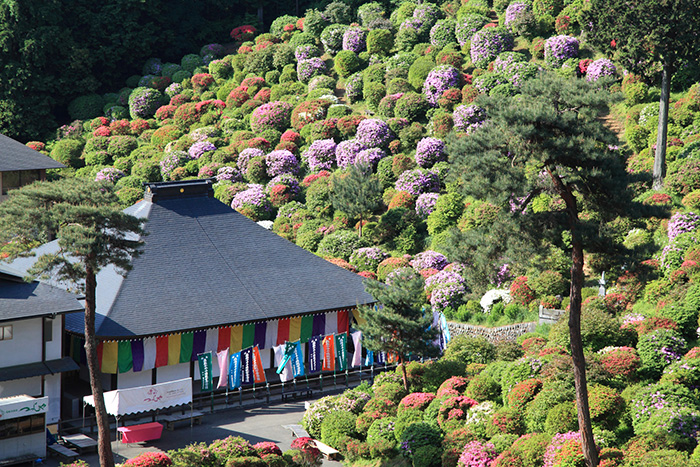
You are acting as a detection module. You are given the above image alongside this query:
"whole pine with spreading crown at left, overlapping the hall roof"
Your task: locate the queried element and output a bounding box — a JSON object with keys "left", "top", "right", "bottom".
{"left": 0, "top": 179, "right": 144, "bottom": 467}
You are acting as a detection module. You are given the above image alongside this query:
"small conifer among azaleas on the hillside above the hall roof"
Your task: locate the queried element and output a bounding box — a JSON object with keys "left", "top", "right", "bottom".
{"left": 331, "top": 164, "right": 382, "bottom": 237}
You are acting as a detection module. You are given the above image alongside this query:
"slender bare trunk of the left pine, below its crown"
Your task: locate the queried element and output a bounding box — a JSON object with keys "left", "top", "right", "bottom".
{"left": 85, "top": 267, "right": 114, "bottom": 467}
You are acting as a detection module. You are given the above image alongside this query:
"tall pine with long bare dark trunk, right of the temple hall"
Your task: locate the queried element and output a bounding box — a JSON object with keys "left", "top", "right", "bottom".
{"left": 448, "top": 75, "right": 644, "bottom": 467}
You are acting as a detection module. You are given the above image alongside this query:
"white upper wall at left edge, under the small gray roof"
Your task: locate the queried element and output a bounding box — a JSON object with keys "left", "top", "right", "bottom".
{"left": 0, "top": 318, "right": 41, "bottom": 368}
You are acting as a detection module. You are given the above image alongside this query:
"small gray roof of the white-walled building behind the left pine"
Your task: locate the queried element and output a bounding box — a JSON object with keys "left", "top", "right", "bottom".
{"left": 0, "top": 265, "right": 84, "bottom": 322}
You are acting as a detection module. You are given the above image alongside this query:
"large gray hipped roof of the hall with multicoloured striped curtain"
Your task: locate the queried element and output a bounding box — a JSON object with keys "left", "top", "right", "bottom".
{"left": 5, "top": 181, "right": 374, "bottom": 338}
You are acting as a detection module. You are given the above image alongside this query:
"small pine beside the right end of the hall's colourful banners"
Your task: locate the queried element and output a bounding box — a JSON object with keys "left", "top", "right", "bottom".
{"left": 358, "top": 270, "right": 440, "bottom": 391}
